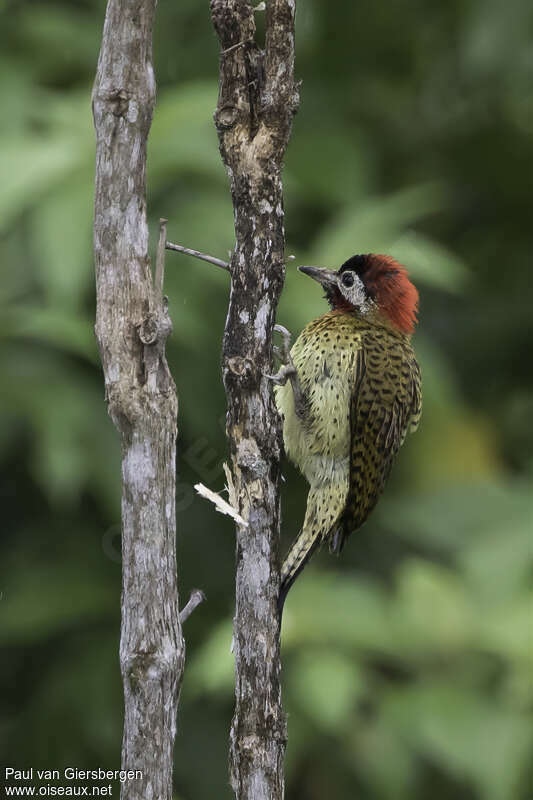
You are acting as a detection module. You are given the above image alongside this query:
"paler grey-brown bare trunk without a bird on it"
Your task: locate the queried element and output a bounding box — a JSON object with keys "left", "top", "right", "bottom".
{"left": 93, "top": 0, "right": 185, "bottom": 800}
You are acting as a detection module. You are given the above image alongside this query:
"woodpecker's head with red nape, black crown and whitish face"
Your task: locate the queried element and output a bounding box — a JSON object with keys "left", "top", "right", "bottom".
{"left": 298, "top": 253, "right": 418, "bottom": 334}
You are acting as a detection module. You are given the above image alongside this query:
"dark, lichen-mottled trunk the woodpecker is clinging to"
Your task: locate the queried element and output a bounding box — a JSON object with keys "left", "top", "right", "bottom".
{"left": 211, "top": 0, "right": 298, "bottom": 800}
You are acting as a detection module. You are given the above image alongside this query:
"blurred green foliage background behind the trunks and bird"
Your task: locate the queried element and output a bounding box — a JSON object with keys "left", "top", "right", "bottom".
{"left": 0, "top": 0, "right": 533, "bottom": 800}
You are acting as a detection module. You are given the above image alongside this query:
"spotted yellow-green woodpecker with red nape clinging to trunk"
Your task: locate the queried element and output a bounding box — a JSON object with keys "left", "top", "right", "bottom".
{"left": 269, "top": 253, "right": 422, "bottom": 614}
